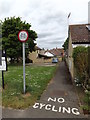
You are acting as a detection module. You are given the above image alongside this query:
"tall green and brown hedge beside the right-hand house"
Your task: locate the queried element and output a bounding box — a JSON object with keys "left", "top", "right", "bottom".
{"left": 73, "top": 46, "right": 89, "bottom": 87}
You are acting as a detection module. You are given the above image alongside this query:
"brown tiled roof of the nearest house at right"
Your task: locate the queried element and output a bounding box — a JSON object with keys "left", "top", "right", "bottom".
{"left": 69, "top": 24, "right": 90, "bottom": 44}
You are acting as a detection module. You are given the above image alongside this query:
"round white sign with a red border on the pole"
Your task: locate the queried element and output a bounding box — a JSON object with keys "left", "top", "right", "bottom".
{"left": 18, "top": 30, "right": 28, "bottom": 42}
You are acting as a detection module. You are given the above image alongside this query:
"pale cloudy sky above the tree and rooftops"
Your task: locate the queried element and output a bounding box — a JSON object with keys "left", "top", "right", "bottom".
{"left": 0, "top": 0, "right": 90, "bottom": 49}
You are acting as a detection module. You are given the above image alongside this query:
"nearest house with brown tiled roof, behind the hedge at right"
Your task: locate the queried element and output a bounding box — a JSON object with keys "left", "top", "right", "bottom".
{"left": 66, "top": 24, "right": 90, "bottom": 79}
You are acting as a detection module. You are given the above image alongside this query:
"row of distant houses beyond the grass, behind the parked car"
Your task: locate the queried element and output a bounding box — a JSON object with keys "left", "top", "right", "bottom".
{"left": 28, "top": 46, "right": 64, "bottom": 63}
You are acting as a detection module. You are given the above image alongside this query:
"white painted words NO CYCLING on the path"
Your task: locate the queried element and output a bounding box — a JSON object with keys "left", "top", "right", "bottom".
{"left": 33, "top": 97, "right": 80, "bottom": 116}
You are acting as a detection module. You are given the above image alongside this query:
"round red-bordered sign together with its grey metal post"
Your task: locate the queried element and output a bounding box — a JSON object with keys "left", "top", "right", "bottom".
{"left": 18, "top": 30, "right": 28, "bottom": 94}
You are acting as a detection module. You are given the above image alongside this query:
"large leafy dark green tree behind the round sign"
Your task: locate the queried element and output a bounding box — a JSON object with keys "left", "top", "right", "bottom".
{"left": 2, "top": 17, "right": 37, "bottom": 61}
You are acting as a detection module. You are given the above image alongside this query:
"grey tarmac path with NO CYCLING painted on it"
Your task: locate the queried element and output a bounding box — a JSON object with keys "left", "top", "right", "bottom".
{"left": 2, "top": 62, "right": 86, "bottom": 118}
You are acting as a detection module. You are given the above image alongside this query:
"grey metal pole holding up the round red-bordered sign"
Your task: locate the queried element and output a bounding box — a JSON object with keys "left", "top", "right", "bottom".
{"left": 23, "top": 42, "right": 26, "bottom": 94}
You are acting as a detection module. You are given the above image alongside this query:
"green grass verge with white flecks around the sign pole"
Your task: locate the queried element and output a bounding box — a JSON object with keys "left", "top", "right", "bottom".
{"left": 2, "top": 66, "right": 56, "bottom": 109}
